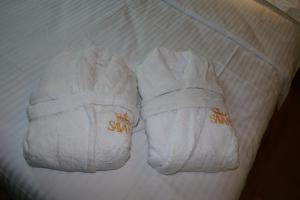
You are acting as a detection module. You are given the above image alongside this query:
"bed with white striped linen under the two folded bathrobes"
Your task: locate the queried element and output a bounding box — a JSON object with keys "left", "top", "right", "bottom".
{"left": 0, "top": 0, "right": 300, "bottom": 200}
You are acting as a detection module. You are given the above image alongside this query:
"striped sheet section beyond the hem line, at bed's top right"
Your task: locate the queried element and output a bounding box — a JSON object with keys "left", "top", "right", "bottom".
{"left": 164, "top": 0, "right": 300, "bottom": 105}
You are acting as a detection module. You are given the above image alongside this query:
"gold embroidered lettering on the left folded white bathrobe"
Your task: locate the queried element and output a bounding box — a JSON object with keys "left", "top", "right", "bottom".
{"left": 107, "top": 112, "right": 132, "bottom": 133}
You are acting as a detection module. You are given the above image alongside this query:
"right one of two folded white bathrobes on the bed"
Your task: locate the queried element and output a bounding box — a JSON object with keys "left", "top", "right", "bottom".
{"left": 137, "top": 48, "right": 238, "bottom": 174}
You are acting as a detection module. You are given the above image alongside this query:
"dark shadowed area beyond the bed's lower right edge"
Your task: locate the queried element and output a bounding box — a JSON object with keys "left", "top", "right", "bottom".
{"left": 240, "top": 71, "right": 300, "bottom": 200}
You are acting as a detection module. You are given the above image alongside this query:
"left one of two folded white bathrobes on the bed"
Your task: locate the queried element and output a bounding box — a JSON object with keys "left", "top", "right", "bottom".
{"left": 24, "top": 47, "right": 138, "bottom": 172}
